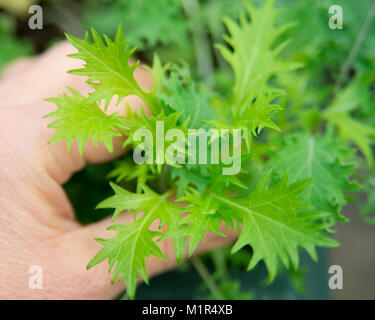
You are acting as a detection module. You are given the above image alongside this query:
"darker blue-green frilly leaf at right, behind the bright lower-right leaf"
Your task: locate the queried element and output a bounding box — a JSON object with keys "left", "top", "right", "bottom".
{"left": 267, "top": 132, "right": 358, "bottom": 221}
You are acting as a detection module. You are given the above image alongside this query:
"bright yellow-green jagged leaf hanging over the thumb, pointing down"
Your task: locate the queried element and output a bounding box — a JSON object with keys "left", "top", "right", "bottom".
{"left": 87, "top": 183, "right": 186, "bottom": 298}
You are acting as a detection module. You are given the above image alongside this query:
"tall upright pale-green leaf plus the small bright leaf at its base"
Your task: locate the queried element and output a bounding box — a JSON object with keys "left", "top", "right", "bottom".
{"left": 211, "top": 1, "right": 300, "bottom": 151}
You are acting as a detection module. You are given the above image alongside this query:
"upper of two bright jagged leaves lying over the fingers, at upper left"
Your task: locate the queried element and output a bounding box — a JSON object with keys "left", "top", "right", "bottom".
{"left": 66, "top": 25, "right": 157, "bottom": 112}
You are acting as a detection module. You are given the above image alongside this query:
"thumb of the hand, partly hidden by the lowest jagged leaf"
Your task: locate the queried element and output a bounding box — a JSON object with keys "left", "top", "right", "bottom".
{"left": 56, "top": 214, "right": 236, "bottom": 299}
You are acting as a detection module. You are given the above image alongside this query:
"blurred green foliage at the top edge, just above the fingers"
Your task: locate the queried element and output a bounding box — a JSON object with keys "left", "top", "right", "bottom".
{"left": 86, "top": 0, "right": 188, "bottom": 49}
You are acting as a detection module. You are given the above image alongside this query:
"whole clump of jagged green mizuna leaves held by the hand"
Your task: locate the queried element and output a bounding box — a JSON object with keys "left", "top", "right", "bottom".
{"left": 47, "top": 1, "right": 375, "bottom": 298}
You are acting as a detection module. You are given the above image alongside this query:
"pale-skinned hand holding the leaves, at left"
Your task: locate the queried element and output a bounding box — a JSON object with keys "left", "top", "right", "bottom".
{"left": 0, "top": 42, "right": 235, "bottom": 299}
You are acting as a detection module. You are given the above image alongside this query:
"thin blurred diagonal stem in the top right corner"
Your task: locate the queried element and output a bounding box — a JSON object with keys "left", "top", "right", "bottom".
{"left": 335, "top": 3, "right": 375, "bottom": 91}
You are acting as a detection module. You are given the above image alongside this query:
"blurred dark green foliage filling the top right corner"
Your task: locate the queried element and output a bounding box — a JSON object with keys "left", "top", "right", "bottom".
{"left": 281, "top": 0, "right": 375, "bottom": 73}
